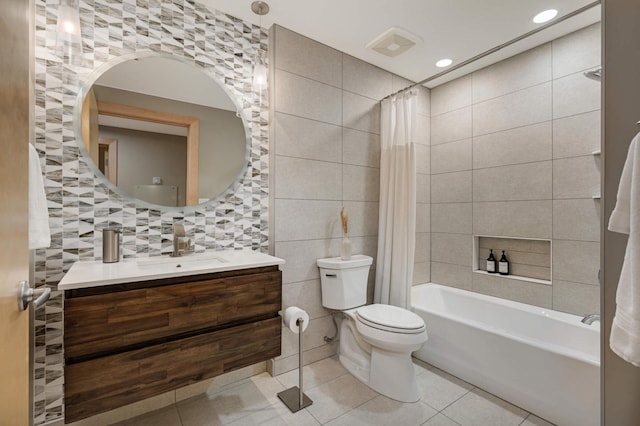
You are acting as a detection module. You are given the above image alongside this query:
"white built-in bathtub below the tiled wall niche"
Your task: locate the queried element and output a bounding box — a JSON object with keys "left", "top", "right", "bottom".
{"left": 411, "top": 284, "right": 600, "bottom": 426}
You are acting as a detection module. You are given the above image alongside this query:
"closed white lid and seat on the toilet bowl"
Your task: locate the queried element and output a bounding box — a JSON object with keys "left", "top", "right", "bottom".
{"left": 356, "top": 304, "right": 425, "bottom": 333}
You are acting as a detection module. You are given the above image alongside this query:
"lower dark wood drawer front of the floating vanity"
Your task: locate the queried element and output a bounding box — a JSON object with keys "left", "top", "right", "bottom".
{"left": 65, "top": 317, "right": 282, "bottom": 422}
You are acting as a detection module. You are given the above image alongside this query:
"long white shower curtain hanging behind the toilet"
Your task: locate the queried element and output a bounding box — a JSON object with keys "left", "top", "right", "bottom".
{"left": 374, "top": 90, "right": 416, "bottom": 308}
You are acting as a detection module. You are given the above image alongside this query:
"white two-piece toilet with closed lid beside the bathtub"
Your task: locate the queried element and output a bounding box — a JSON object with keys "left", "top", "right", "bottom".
{"left": 317, "top": 255, "right": 427, "bottom": 402}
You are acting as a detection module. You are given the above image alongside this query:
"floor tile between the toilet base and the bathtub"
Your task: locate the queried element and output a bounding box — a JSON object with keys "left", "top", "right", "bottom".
{"left": 416, "top": 368, "right": 473, "bottom": 411}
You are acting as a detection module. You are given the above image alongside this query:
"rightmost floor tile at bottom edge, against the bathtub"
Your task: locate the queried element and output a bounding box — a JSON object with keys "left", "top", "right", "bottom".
{"left": 442, "top": 388, "right": 529, "bottom": 426}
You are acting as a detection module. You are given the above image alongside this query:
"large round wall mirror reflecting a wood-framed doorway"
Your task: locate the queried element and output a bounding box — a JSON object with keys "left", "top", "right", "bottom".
{"left": 76, "top": 52, "right": 249, "bottom": 207}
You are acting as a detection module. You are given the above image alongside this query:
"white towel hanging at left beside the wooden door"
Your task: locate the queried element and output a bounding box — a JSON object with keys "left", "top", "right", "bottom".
{"left": 28, "top": 144, "right": 51, "bottom": 250}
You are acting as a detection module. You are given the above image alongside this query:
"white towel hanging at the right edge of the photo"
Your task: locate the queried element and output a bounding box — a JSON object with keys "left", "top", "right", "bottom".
{"left": 609, "top": 133, "right": 640, "bottom": 367}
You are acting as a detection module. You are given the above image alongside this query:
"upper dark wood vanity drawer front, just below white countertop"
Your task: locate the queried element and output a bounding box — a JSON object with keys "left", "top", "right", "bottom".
{"left": 64, "top": 267, "right": 282, "bottom": 364}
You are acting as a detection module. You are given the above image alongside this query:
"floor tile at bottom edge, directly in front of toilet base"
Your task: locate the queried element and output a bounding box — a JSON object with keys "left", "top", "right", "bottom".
{"left": 327, "top": 395, "right": 437, "bottom": 426}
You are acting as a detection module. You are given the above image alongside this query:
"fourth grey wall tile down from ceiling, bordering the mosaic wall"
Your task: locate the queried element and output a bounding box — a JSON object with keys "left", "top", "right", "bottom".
{"left": 275, "top": 156, "right": 342, "bottom": 200}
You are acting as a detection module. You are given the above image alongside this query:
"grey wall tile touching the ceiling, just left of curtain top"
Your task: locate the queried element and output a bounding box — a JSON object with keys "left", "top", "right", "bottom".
{"left": 342, "top": 55, "right": 392, "bottom": 100}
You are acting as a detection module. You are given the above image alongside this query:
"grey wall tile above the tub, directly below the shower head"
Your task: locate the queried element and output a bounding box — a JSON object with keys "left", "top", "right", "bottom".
{"left": 553, "top": 72, "right": 601, "bottom": 119}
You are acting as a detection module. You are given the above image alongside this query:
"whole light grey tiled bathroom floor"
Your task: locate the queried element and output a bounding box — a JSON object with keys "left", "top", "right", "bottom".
{"left": 112, "top": 357, "right": 552, "bottom": 426}
